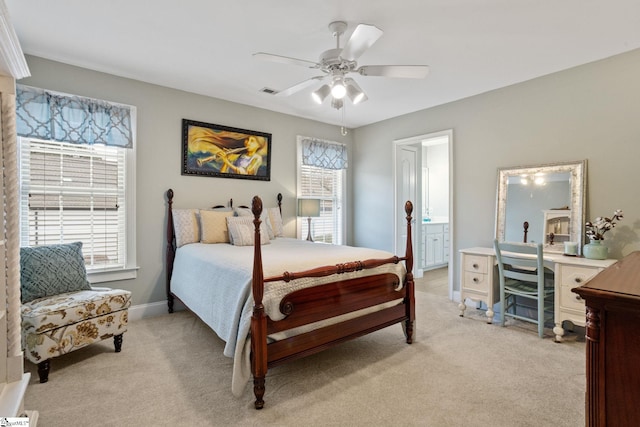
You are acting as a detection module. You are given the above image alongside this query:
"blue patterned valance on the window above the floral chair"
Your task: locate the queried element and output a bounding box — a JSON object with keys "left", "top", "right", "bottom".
{"left": 16, "top": 85, "right": 135, "bottom": 148}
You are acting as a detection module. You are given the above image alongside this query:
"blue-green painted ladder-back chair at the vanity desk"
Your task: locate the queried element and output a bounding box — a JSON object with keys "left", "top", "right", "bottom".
{"left": 493, "top": 240, "right": 554, "bottom": 338}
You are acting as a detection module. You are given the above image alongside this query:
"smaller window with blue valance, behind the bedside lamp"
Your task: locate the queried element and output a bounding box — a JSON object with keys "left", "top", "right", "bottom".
{"left": 298, "top": 137, "right": 346, "bottom": 245}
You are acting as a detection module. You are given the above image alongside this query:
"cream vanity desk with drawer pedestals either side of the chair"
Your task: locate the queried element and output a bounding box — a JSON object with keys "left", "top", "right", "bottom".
{"left": 458, "top": 247, "right": 616, "bottom": 342}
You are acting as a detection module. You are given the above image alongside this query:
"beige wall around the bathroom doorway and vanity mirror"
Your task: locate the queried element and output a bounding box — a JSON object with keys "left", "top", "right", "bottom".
{"left": 352, "top": 50, "right": 640, "bottom": 289}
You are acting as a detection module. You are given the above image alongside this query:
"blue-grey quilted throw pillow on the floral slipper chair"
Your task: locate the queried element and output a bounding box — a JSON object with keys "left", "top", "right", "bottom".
{"left": 20, "top": 242, "right": 91, "bottom": 303}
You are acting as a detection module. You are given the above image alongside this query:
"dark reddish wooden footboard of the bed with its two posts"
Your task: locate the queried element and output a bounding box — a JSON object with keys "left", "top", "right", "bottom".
{"left": 251, "top": 196, "right": 415, "bottom": 409}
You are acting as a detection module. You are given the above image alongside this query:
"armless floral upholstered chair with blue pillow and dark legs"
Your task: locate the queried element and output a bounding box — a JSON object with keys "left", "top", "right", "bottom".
{"left": 20, "top": 242, "right": 131, "bottom": 383}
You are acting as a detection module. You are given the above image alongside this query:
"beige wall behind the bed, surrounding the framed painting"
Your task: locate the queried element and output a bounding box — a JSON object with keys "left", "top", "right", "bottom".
{"left": 18, "top": 57, "right": 351, "bottom": 304}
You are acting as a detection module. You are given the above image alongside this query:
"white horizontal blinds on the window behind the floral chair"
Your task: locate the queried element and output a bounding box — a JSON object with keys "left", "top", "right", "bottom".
{"left": 20, "top": 138, "right": 126, "bottom": 270}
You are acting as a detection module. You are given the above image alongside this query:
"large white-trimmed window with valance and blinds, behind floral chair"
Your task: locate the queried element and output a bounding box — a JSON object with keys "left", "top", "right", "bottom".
{"left": 16, "top": 85, "right": 136, "bottom": 283}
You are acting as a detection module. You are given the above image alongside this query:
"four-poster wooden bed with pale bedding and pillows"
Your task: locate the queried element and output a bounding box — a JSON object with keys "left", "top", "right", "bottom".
{"left": 166, "top": 190, "right": 415, "bottom": 409}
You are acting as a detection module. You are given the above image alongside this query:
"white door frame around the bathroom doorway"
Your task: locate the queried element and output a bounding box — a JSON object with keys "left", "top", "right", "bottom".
{"left": 393, "top": 129, "right": 455, "bottom": 300}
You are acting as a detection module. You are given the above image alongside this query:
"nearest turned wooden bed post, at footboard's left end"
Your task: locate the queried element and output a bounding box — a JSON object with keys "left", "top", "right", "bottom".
{"left": 251, "top": 196, "right": 267, "bottom": 409}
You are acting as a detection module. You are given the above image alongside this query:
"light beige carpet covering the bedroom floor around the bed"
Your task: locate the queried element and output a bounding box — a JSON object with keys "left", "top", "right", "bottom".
{"left": 25, "top": 270, "right": 585, "bottom": 427}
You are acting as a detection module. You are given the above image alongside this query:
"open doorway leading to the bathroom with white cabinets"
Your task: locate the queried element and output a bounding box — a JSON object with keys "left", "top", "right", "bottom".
{"left": 394, "top": 130, "right": 453, "bottom": 299}
